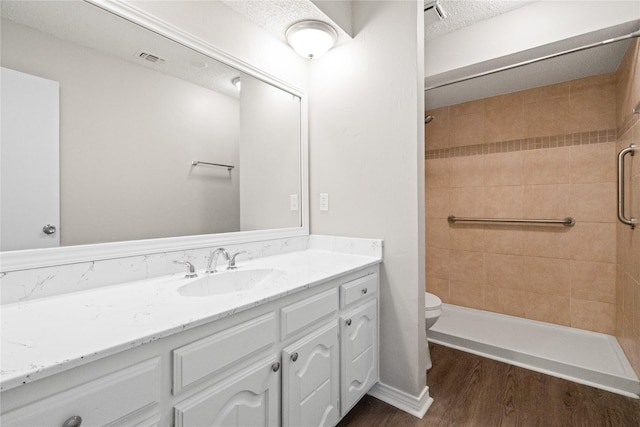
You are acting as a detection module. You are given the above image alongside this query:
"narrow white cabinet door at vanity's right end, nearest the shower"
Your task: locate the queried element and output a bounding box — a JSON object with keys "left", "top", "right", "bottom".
{"left": 340, "top": 299, "right": 378, "bottom": 416}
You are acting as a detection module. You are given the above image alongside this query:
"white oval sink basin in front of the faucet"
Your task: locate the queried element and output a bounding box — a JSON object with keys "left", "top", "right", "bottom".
{"left": 178, "top": 269, "right": 281, "bottom": 297}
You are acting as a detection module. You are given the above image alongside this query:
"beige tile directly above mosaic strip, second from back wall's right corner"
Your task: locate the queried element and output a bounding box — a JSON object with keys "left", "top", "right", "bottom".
{"left": 524, "top": 94, "right": 572, "bottom": 138}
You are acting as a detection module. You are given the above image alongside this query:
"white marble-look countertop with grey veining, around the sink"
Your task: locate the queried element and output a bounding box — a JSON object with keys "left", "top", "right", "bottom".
{"left": 0, "top": 249, "right": 381, "bottom": 390}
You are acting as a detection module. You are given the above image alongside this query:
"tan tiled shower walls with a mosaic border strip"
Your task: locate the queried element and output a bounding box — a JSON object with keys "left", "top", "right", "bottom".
{"left": 425, "top": 39, "right": 640, "bottom": 373}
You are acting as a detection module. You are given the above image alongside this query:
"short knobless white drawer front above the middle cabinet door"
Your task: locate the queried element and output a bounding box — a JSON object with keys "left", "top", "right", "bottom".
{"left": 280, "top": 288, "right": 338, "bottom": 339}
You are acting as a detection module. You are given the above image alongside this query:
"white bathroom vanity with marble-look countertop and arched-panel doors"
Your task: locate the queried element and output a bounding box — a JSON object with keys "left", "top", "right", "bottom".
{"left": 1, "top": 249, "right": 380, "bottom": 427}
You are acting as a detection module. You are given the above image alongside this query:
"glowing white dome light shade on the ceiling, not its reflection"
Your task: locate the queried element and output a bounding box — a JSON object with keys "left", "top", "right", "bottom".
{"left": 286, "top": 21, "right": 338, "bottom": 59}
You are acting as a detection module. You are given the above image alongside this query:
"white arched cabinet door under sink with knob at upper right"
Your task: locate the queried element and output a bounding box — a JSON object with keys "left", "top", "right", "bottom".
{"left": 174, "top": 358, "right": 280, "bottom": 427}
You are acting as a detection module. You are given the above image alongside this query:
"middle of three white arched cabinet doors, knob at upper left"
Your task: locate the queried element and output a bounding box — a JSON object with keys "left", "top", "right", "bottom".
{"left": 282, "top": 321, "right": 340, "bottom": 427}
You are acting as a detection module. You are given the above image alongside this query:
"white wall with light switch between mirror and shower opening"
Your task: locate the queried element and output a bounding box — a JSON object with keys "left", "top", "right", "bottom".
{"left": 309, "top": 1, "right": 426, "bottom": 397}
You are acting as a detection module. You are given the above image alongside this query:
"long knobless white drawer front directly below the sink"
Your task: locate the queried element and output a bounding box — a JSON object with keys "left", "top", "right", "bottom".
{"left": 173, "top": 313, "right": 277, "bottom": 395}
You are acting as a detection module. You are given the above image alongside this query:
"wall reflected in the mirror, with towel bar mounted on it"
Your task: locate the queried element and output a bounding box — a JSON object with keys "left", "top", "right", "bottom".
{"left": 2, "top": 20, "right": 239, "bottom": 246}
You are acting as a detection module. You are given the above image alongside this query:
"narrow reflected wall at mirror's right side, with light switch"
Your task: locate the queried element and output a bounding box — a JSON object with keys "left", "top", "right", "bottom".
{"left": 238, "top": 77, "right": 302, "bottom": 231}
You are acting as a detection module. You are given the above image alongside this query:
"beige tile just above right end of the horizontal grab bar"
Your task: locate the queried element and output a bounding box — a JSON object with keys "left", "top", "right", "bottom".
{"left": 524, "top": 184, "right": 573, "bottom": 219}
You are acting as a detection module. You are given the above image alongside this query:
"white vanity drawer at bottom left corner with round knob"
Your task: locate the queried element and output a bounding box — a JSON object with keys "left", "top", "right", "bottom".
{"left": 2, "top": 357, "right": 160, "bottom": 427}
